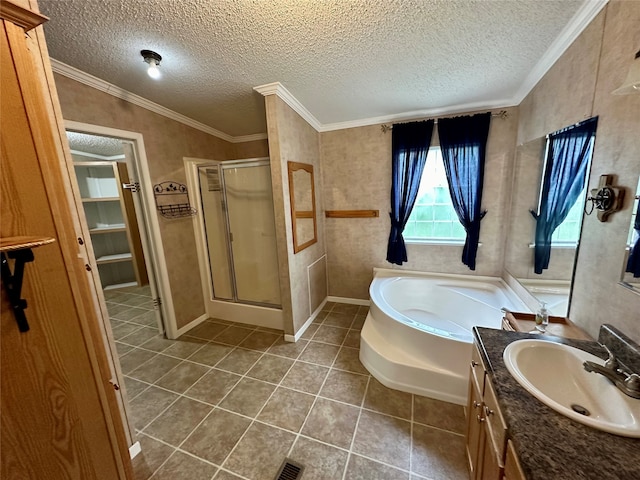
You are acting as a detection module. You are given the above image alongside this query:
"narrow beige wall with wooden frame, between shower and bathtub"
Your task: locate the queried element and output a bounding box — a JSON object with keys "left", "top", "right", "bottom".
{"left": 265, "top": 95, "right": 325, "bottom": 335}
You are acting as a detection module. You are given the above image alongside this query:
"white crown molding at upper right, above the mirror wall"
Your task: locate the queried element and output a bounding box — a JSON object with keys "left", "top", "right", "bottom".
{"left": 513, "top": 0, "right": 609, "bottom": 105}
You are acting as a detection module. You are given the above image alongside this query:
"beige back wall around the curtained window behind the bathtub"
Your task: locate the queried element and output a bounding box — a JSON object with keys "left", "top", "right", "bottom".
{"left": 321, "top": 108, "right": 518, "bottom": 299}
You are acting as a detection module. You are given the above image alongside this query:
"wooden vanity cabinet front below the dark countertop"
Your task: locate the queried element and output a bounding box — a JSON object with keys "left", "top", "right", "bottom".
{"left": 466, "top": 344, "right": 507, "bottom": 480}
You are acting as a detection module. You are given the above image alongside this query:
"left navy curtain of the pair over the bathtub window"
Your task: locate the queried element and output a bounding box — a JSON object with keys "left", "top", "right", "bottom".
{"left": 387, "top": 120, "right": 434, "bottom": 265}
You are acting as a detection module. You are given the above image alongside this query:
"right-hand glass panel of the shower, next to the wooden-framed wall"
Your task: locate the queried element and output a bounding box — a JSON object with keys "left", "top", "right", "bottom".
{"left": 222, "top": 164, "right": 280, "bottom": 305}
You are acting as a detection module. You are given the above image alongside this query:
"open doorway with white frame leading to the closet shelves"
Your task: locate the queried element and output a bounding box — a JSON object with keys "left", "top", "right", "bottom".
{"left": 65, "top": 121, "right": 172, "bottom": 338}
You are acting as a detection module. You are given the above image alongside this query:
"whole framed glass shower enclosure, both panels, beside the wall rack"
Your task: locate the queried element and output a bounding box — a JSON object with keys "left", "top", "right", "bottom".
{"left": 197, "top": 159, "right": 280, "bottom": 308}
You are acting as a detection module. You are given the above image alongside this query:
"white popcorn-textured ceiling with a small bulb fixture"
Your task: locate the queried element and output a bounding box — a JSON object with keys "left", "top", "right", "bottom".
{"left": 39, "top": 0, "right": 593, "bottom": 136}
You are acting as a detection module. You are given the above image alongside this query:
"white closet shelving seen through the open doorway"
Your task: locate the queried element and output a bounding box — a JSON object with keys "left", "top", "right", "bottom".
{"left": 74, "top": 160, "right": 148, "bottom": 288}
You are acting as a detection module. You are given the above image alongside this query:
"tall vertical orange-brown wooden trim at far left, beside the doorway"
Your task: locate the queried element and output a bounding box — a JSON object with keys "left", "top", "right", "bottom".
{"left": 9, "top": 0, "right": 133, "bottom": 478}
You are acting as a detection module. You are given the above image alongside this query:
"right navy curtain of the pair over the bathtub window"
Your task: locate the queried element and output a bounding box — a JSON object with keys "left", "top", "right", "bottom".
{"left": 438, "top": 113, "right": 491, "bottom": 270}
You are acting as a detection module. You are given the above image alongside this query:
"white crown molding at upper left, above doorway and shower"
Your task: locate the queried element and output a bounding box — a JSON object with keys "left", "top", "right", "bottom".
{"left": 51, "top": 58, "right": 267, "bottom": 143}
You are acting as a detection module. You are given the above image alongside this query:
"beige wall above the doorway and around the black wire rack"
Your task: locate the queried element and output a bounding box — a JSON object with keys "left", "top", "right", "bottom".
{"left": 55, "top": 74, "right": 236, "bottom": 328}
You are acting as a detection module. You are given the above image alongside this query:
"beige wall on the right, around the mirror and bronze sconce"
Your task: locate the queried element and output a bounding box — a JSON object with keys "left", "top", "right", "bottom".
{"left": 519, "top": 0, "right": 640, "bottom": 342}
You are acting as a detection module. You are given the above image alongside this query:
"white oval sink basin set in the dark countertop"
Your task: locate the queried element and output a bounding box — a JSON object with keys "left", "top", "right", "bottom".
{"left": 503, "top": 340, "right": 640, "bottom": 438}
